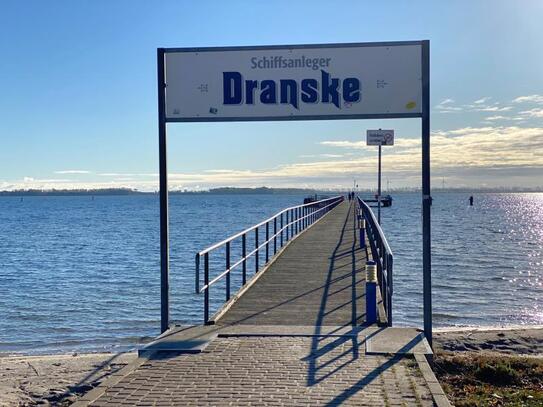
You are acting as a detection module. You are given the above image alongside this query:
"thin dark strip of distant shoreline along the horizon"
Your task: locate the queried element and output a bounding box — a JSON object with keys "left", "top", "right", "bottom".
{"left": 0, "top": 187, "right": 543, "bottom": 197}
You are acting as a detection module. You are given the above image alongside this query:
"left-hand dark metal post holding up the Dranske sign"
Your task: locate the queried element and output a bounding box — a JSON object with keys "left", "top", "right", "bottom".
{"left": 157, "top": 48, "right": 170, "bottom": 332}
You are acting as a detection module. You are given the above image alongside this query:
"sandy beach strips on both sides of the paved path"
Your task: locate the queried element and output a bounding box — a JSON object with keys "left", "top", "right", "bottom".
{"left": 0, "top": 327, "right": 543, "bottom": 406}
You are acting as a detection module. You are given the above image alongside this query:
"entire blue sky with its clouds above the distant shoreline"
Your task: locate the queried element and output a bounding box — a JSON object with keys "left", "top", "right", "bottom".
{"left": 0, "top": 0, "right": 543, "bottom": 190}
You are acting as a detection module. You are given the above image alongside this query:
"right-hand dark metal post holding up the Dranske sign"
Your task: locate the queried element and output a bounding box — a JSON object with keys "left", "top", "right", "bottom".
{"left": 422, "top": 41, "right": 432, "bottom": 346}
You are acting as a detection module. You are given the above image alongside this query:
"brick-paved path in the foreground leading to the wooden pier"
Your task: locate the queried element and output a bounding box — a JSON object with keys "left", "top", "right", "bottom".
{"left": 91, "top": 336, "right": 433, "bottom": 407}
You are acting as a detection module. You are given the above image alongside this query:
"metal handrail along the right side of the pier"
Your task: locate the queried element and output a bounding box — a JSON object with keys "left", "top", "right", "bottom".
{"left": 357, "top": 198, "right": 394, "bottom": 325}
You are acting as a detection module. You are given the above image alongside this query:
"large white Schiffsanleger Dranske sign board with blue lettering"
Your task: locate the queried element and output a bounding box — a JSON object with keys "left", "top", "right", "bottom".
{"left": 164, "top": 42, "right": 422, "bottom": 121}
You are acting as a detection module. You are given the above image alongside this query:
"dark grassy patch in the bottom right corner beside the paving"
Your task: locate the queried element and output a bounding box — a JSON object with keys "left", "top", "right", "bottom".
{"left": 434, "top": 353, "right": 543, "bottom": 407}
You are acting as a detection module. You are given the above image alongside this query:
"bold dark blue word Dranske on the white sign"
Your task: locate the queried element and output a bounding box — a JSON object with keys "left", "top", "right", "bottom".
{"left": 222, "top": 70, "right": 361, "bottom": 109}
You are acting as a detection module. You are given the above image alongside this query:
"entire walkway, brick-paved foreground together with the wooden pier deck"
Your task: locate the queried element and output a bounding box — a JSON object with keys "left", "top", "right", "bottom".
{"left": 75, "top": 201, "right": 449, "bottom": 407}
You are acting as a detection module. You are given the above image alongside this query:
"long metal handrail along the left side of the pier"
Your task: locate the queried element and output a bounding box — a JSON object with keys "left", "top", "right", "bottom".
{"left": 195, "top": 196, "right": 344, "bottom": 324}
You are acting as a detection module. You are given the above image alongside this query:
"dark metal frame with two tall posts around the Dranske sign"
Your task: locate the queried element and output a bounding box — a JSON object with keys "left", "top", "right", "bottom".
{"left": 157, "top": 40, "right": 432, "bottom": 345}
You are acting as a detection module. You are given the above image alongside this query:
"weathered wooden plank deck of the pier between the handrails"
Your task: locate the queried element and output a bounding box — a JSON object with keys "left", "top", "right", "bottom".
{"left": 217, "top": 201, "right": 367, "bottom": 326}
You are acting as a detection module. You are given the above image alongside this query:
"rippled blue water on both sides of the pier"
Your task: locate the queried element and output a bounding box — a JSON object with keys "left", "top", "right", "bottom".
{"left": 0, "top": 193, "right": 543, "bottom": 352}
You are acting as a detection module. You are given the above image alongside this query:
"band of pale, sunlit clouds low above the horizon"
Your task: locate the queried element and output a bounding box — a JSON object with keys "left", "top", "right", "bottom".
{"left": 4, "top": 126, "right": 543, "bottom": 191}
